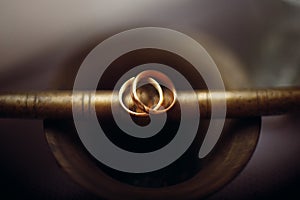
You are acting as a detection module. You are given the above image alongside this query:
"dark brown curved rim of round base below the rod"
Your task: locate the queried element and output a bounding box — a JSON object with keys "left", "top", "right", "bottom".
{"left": 44, "top": 118, "right": 261, "bottom": 199}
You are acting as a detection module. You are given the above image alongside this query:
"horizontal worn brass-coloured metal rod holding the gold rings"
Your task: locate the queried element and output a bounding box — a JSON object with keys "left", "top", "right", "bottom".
{"left": 0, "top": 88, "right": 300, "bottom": 119}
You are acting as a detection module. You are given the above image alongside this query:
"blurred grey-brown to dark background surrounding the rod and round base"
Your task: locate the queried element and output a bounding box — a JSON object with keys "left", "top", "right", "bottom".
{"left": 0, "top": 0, "right": 300, "bottom": 200}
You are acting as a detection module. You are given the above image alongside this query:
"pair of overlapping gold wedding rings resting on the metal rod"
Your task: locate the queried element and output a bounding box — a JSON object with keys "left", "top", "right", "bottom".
{"left": 119, "top": 70, "right": 177, "bottom": 116}
